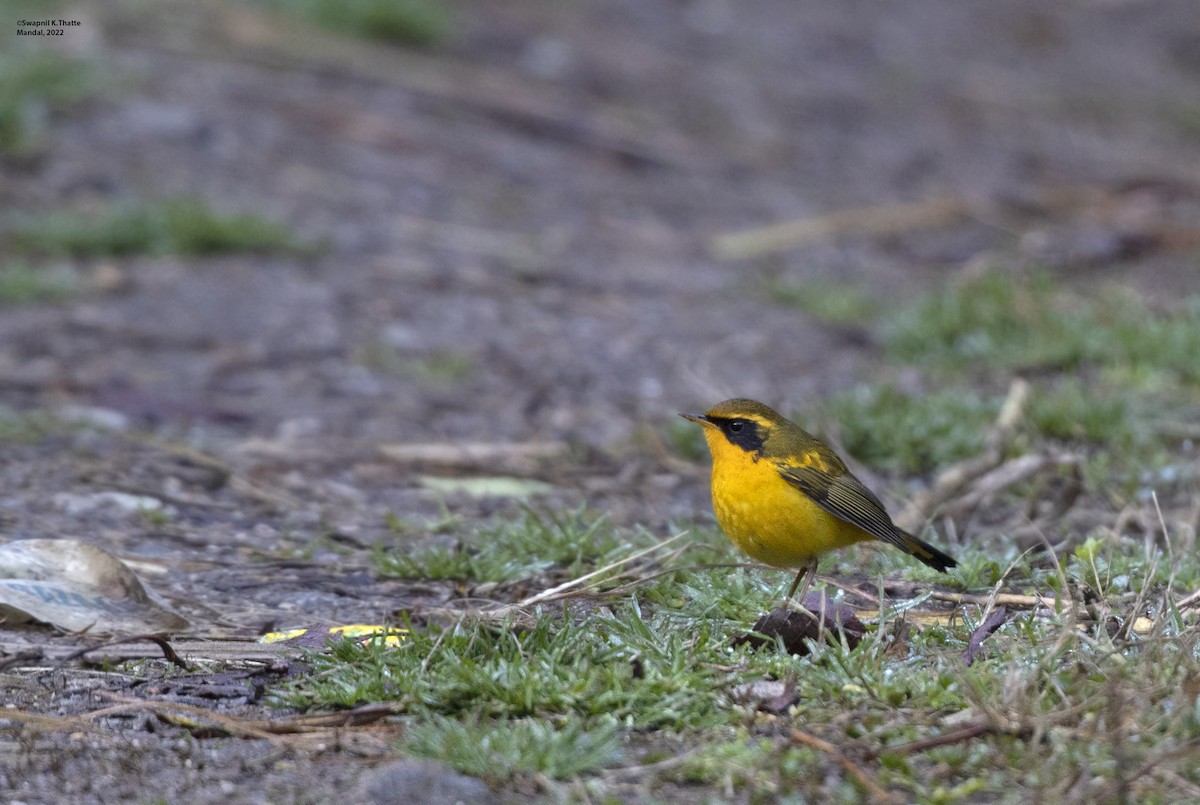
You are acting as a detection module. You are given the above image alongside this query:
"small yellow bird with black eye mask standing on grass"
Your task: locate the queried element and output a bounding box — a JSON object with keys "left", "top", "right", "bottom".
{"left": 679, "top": 400, "right": 958, "bottom": 603}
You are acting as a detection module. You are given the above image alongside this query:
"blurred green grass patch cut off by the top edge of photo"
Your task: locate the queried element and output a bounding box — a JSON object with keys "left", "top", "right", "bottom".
{"left": 274, "top": 0, "right": 454, "bottom": 47}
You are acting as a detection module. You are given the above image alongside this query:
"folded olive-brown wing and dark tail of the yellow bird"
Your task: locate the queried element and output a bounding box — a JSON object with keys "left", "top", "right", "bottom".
{"left": 779, "top": 467, "right": 958, "bottom": 571}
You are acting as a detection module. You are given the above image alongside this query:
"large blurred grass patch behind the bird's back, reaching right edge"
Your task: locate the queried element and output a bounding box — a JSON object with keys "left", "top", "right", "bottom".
{"left": 859, "top": 272, "right": 1200, "bottom": 494}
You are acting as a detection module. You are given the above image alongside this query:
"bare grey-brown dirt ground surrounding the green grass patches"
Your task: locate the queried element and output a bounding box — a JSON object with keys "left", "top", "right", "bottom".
{"left": 0, "top": 0, "right": 1200, "bottom": 803}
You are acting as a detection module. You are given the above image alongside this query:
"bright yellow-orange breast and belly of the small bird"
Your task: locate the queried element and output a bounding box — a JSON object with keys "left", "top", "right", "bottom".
{"left": 706, "top": 433, "right": 871, "bottom": 567}
